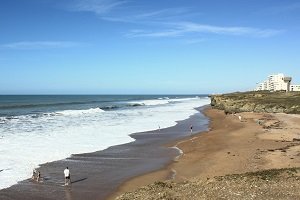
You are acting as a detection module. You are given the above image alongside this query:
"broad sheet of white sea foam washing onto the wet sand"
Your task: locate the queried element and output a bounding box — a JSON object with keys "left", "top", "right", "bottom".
{"left": 0, "top": 98, "right": 209, "bottom": 189}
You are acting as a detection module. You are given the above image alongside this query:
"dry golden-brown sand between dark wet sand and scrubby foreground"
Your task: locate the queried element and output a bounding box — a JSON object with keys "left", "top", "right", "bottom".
{"left": 110, "top": 108, "right": 300, "bottom": 199}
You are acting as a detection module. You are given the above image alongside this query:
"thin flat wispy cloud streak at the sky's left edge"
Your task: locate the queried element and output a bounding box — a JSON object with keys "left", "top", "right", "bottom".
{"left": 0, "top": 41, "right": 81, "bottom": 50}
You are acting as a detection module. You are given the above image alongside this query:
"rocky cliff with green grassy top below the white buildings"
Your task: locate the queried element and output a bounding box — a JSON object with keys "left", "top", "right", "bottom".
{"left": 211, "top": 91, "right": 300, "bottom": 114}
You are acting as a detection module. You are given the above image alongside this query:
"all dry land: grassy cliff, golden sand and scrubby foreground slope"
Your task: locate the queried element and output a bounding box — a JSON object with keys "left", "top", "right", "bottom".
{"left": 111, "top": 92, "right": 300, "bottom": 200}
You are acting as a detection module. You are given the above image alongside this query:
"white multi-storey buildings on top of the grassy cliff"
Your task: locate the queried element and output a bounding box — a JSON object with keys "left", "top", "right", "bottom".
{"left": 255, "top": 73, "right": 300, "bottom": 92}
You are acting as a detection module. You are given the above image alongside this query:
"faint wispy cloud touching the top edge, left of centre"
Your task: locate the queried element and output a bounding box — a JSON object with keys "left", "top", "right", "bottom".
{"left": 69, "top": 0, "right": 127, "bottom": 15}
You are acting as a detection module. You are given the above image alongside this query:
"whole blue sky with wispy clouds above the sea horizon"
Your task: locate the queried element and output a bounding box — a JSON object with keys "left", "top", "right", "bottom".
{"left": 0, "top": 0, "right": 300, "bottom": 94}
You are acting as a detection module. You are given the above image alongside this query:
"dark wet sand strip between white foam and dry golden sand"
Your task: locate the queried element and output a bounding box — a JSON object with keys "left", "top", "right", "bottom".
{"left": 0, "top": 107, "right": 208, "bottom": 200}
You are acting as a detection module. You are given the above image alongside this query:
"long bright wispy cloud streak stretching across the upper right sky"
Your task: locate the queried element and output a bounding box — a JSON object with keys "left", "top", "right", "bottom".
{"left": 127, "top": 22, "right": 284, "bottom": 37}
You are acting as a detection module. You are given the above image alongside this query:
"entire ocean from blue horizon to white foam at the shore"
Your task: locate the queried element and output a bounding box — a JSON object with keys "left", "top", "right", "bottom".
{"left": 0, "top": 95, "right": 210, "bottom": 189}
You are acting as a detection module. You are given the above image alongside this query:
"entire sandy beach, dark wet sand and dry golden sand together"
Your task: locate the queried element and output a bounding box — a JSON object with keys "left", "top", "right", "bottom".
{"left": 0, "top": 104, "right": 300, "bottom": 200}
